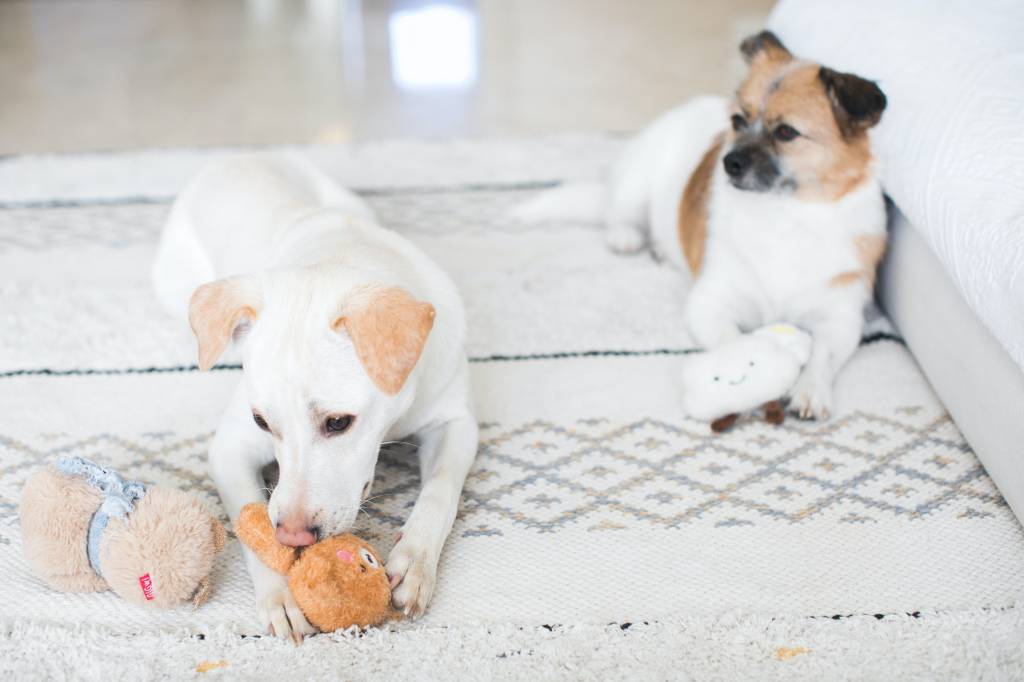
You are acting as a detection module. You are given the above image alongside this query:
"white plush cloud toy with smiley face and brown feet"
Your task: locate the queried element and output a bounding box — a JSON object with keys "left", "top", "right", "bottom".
{"left": 682, "top": 325, "right": 812, "bottom": 431}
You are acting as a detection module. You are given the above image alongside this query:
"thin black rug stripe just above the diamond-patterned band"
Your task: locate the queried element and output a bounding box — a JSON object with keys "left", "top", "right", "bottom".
{"left": 0, "top": 332, "right": 906, "bottom": 379}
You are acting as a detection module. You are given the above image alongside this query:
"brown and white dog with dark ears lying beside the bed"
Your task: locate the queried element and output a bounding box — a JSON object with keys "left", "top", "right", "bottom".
{"left": 517, "top": 32, "right": 886, "bottom": 418}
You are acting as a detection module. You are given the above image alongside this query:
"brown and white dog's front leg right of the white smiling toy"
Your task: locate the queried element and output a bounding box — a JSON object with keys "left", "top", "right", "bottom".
{"left": 790, "top": 303, "right": 864, "bottom": 419}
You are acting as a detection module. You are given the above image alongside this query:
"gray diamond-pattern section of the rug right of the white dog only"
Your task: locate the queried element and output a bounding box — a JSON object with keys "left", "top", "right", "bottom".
{"left": 462, "top": 412, "right": 1005, "bottom": 532}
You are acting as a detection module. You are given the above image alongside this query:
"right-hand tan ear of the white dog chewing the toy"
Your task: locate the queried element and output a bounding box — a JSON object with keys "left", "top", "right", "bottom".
{"left": 332, "top": 287, "right": 434, "bottom": 395}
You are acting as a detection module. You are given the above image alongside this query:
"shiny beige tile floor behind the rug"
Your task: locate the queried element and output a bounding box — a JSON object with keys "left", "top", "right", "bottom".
{"left": 0, "top": 0, "right": 773, "bottom": 154}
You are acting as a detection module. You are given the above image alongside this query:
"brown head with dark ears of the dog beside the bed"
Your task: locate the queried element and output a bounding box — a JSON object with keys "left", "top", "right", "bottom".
{"left": 723, "top": 31, "right": 886, "bottom": 201}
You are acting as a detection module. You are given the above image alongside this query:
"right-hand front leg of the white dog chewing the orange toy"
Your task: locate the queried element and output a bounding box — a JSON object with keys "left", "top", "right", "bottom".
{"left": 387, "top": 415, "right": 478, "bottom": 617}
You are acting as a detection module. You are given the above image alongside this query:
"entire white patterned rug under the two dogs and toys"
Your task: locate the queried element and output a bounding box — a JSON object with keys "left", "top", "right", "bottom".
{"left": 0, "top": 137, "right": 1024, "bottom": 679}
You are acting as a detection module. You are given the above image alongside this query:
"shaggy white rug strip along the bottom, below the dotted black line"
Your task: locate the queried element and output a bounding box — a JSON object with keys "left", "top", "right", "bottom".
{"left": 0, "top": 607, "right": 1024, "bottom": 682}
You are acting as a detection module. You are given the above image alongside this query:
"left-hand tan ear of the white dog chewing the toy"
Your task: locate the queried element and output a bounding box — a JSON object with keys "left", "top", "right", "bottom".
{"left": 188, "top": 275, "right": 263, "bottom": 372}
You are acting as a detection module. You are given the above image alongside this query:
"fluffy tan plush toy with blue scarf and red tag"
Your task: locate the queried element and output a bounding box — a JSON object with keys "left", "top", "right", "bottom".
{"left": 18, "top": 457, "right": 225, "bottom": 608}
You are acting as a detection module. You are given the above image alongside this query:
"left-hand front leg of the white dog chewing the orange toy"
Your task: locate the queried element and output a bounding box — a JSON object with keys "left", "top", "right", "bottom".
{"left": 210, "top": 386, "right": 316, "bottom": 642}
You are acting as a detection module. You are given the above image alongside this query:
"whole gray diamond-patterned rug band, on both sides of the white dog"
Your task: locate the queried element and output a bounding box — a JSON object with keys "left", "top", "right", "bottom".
{"left": 0, "top": 405, "right": 1009, "bottom": 542}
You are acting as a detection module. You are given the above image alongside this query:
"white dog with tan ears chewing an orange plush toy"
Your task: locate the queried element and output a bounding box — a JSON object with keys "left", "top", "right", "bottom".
{"left": 154, "top": 157, "right": 477, "bottom": 639}
